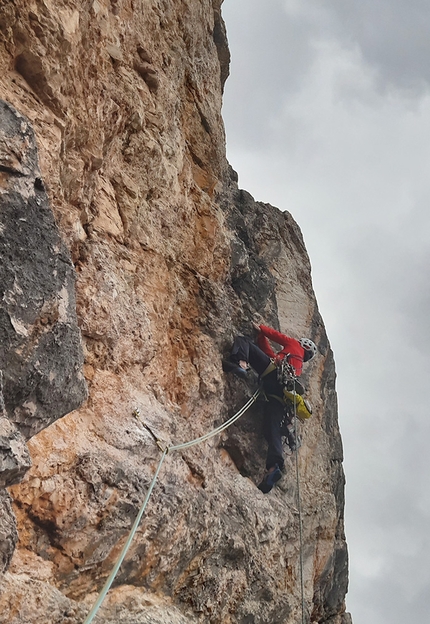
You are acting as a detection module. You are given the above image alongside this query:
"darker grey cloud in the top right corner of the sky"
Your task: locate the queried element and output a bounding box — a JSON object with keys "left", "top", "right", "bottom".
{"left": 279, "top": 0, "right": 430, "bottom": 91}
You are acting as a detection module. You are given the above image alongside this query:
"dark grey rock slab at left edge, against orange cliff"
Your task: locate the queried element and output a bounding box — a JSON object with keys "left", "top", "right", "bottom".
{"left": 0, "top": 101, "right": 86, "bottom": 439}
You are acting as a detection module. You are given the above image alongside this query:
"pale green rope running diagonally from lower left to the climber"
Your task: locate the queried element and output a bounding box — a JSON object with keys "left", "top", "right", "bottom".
{"left": 84, "top": 388, "right": 261, "bottom": 624}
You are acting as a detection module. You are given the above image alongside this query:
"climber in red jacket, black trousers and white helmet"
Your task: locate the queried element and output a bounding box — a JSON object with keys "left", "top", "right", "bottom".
{"left": 223, "top": 323, "right": 317, "bottom": 494}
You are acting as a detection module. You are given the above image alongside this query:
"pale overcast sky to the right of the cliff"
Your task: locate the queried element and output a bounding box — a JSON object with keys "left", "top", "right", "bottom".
{"left": 223, "top": 0, "right": 430, "bottom": 624}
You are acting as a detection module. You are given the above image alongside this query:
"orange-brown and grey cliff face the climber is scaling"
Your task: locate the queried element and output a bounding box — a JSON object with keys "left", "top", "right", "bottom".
{"left": 0, "top": 0, "right": 350, "bottom": 624}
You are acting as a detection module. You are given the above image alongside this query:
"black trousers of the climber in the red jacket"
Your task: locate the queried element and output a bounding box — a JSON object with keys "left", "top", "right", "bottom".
{"left": 230, "top": 336, "right": 285, "bottom": 470}
